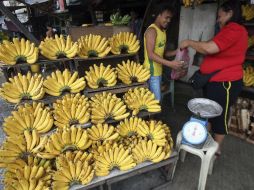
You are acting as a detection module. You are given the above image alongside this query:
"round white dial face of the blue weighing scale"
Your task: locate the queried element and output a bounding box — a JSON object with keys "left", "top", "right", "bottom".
{"left": 182, "top": 121, "right": 207, "bottom": 144}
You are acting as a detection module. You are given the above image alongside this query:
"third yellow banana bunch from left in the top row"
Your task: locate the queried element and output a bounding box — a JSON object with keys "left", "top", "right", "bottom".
{"left": 78, "top": 34, "right": 111, "bottom": 58}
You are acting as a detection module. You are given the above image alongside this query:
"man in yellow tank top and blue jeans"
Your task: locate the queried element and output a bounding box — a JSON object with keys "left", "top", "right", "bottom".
{"left": 144, "top": 5, "right": 183, "bottom": 101}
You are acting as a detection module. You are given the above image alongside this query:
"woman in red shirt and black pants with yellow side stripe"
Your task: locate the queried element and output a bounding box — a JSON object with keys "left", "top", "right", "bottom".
{"left": 180, "top": 0, "right": 248, "bottom": 155}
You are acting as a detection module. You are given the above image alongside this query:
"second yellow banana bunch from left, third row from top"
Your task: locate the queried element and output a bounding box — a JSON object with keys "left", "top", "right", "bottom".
{"left": 53, "top": 93, "right": 90, "bottom": 128}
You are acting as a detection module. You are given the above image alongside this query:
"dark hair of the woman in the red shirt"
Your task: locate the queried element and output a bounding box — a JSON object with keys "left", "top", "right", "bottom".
{"left": 220, "top": 0, "right": 242, "bottom": 24}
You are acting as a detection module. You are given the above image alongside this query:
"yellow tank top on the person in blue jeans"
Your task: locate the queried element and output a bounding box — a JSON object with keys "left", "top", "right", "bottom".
{"left": 144, "top": 24, "right": 166, "bottom": 76}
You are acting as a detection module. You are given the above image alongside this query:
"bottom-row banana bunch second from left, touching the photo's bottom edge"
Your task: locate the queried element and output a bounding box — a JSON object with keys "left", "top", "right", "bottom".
{"left": 52, "top": 151, "right": 95, "bottom": 190}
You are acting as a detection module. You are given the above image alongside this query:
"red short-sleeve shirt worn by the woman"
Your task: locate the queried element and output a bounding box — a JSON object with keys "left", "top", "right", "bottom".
{"left": 200, "top": 22, "right": 248, "bottom": 82}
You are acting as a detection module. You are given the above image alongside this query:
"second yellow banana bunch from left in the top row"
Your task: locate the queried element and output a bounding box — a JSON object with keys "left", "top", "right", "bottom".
{"left": 39, "top": 35, "right": 78, "bottom": 60}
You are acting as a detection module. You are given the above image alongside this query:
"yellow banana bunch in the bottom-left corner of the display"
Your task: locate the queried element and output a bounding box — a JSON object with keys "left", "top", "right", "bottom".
{"left": 4, "top": 156, "right": 52, "bottom": 190}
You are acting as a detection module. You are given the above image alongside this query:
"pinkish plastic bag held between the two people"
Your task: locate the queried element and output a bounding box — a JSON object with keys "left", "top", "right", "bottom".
{"left": 171, "top": 48, "right": 190, "bottom": 80}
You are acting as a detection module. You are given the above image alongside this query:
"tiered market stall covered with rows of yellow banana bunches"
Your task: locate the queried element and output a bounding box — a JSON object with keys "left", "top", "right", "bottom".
{"left": 0, "top": 27, "right": 178, "bottom": 189}
